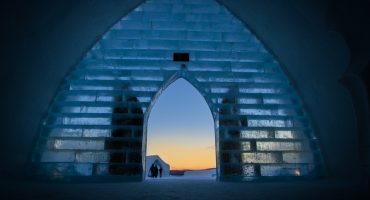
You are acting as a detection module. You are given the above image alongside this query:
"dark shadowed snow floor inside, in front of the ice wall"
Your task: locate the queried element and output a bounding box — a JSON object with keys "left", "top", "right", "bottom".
{"left": 0, "top": 179, "right": 370, "bottom": 200}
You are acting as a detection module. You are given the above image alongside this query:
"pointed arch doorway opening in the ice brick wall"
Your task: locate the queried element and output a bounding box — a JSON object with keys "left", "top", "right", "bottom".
{"left": 143, "top": 75, "right": 216, "bottom": 179}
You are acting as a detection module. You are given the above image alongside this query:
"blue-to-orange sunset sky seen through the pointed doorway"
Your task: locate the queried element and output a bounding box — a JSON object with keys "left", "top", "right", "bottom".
{"left": 147, "top": 79, "right": 216, "bottom": 170}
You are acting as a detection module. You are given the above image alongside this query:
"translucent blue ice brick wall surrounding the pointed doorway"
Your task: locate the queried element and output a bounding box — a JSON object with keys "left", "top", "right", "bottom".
{"left": 33, "top": 0, "right": 321, "bottom": 180}
